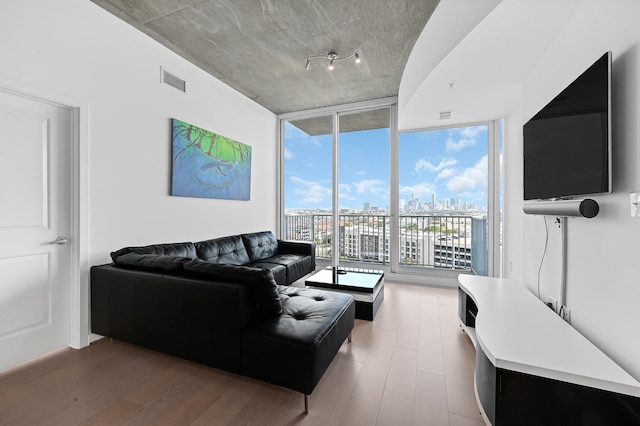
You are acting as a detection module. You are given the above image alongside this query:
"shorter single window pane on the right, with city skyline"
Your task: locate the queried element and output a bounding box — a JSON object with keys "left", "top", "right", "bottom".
{"left": 399, "top": 122, "right": 499, "bottom": 275}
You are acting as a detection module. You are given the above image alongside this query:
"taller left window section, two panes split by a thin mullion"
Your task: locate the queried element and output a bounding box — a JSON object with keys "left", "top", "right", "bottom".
{"left": 280, "top": 102, "right": 391, "bottom": 265}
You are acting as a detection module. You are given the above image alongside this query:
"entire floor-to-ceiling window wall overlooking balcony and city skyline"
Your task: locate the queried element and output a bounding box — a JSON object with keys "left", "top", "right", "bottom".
{"left": 279, "top": 100, "right": 501, "bottom": 277}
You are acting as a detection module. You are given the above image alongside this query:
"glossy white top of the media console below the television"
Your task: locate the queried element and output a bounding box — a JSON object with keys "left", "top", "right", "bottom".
{"left": 458, "top": 275, "right": 640, "bottom": 397}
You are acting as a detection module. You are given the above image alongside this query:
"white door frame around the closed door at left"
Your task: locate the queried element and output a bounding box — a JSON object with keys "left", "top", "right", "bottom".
{"left": 0, "top": 76, "right": 89, "bottom": 349}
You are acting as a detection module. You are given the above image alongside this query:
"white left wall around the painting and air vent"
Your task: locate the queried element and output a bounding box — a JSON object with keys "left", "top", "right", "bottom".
{"left": 0, "top": 0, "right": 276, "bottom": 344}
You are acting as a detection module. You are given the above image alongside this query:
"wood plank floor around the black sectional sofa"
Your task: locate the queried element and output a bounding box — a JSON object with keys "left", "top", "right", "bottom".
{"left": 0, "top": 282, "right": 484, "bottom": 426}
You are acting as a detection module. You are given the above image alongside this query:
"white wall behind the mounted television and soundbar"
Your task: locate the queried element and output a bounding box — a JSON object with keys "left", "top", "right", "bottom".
{"left": 505, "top": 0, "right": 640, "bottom": 378}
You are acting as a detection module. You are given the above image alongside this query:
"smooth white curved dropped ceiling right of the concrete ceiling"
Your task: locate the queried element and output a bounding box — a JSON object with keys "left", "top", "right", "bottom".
{"left": 398, "top": 0, "right": 584, "bottom": 131}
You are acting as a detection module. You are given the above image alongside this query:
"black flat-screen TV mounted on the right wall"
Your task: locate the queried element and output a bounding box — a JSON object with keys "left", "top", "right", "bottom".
{"left": 523, "top": 52, "right": 611, "bottom": 200}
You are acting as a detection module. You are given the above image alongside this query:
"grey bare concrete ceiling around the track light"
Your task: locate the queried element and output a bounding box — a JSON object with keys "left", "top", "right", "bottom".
{"left": 91, "top": 0, "right": 439, "bottom": 120}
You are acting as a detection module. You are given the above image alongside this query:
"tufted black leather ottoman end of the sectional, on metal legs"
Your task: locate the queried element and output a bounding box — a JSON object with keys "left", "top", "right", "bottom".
{"left": 242, "top": 286, "right": 355, "bottom": 411}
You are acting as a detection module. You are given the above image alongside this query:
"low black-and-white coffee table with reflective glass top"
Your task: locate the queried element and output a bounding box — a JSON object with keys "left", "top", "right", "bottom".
{"left": 305, "top": 266, "right": 384, "bottom": 321}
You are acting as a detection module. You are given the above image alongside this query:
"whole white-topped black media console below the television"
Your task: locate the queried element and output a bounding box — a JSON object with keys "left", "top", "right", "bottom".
{"left": 458, "top": 275, "right": 640, "bottom": 426}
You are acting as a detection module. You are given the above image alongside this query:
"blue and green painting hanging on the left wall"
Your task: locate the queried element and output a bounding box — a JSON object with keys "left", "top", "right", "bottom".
{"left": 171, "top": 118, "right": 251, "bottom": 200}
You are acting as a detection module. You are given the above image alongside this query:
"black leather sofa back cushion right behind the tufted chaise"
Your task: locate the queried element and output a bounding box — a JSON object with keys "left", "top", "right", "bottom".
{"left": 184, "top": 259, "right": 282, "bottom": 316}
